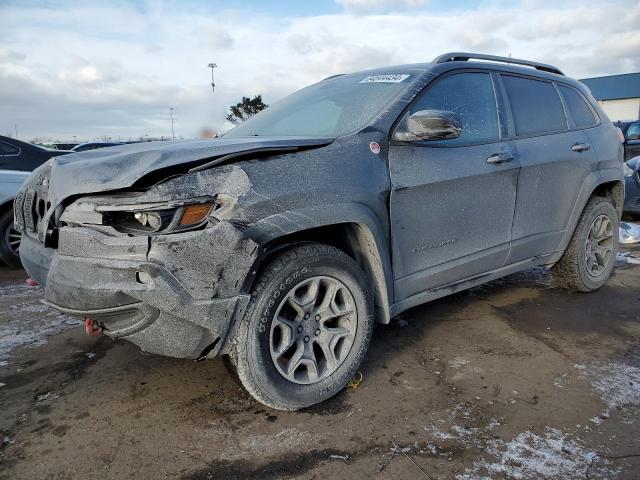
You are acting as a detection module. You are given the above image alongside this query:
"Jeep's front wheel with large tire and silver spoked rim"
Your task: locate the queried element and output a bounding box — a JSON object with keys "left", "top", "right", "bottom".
{"left": 232, "top": 244, "right": 374, "bottom": 410}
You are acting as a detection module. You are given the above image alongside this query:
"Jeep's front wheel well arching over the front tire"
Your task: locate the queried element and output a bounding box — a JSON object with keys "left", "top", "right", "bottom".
{"left": 249, "top": 223, "right": 391, "bottom": 323}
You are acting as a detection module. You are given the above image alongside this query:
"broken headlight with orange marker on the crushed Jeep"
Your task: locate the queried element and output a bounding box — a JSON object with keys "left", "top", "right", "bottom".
{"left": 60, "top": 193, "right": 224, "bottom": 235}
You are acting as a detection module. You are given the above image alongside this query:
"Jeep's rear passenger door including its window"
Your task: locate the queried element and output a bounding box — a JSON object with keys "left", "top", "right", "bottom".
{"left": 501, "top": 73, "right": 596, "bottom": 263}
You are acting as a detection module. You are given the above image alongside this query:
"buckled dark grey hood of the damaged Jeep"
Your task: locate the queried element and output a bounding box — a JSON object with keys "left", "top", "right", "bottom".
{"left": 49, "top": 137, "right": 333, "bottom": 205}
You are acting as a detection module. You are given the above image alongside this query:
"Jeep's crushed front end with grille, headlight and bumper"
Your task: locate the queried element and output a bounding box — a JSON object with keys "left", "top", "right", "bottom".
{"left": 14, "top": 161, "right": 258, "bottom": 358}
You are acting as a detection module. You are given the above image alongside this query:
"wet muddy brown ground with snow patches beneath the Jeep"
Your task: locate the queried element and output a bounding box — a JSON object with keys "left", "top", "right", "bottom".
{"left": 0, "top": 249, "right": 640, "bottom": 479}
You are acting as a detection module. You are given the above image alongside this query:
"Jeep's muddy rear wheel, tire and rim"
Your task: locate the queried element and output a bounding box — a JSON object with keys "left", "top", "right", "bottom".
{"left": 551, "top": 197, "right": 620, "bottom": 292}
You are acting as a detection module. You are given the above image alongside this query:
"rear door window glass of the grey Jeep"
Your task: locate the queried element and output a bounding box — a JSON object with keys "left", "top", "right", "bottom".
{"left": 502, "top": 75, "right": 567, "bottom": 135}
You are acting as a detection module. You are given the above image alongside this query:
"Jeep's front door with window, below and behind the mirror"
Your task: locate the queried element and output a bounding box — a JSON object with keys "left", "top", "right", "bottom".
{"left": 389, "top": 71, "right": 518, "bottom": 301}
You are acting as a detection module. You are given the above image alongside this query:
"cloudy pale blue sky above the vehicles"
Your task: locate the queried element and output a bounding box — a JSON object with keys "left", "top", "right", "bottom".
{"left": 0, "top": 0, "right": 640, "bottom": 141}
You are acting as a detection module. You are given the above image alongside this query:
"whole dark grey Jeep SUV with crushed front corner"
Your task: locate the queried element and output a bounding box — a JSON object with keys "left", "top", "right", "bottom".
{"left": 15, "top": 53, "right": 624, "bottom": 410}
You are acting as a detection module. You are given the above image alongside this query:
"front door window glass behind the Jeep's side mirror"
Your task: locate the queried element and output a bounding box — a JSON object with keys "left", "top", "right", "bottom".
{"left": 399, "top": 73, "right": 498, "bottom": 145}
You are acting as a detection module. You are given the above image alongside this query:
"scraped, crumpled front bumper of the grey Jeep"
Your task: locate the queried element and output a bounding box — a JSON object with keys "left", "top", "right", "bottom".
{"left": 20, "top": 222, "right": 258, "bottom": 358}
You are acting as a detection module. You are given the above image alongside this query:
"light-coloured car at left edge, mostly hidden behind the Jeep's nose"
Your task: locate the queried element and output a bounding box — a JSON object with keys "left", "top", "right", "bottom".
{"left": 0, "top": 170, "right": 31, "bottom": 267}
